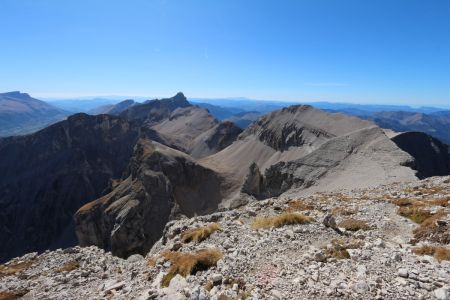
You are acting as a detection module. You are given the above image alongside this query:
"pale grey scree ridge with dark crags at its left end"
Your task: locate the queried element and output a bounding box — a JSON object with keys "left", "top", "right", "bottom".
{"left": 243, "top": 126, "right": 416, "bottom": 198}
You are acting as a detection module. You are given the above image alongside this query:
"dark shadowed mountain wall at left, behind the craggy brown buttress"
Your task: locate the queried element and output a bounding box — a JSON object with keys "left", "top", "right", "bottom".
{"left": 0, "top": 114, "right": 139, "bottom": 260}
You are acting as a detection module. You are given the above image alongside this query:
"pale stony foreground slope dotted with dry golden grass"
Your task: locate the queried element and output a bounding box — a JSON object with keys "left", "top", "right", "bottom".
{"left": 0, "top": 177, "right": 450, "bottom": 300}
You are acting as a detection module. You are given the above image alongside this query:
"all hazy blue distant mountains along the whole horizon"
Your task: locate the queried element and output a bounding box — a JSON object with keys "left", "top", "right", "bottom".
{"left": 0, "top": 92, "right": 450, "bottom": 144}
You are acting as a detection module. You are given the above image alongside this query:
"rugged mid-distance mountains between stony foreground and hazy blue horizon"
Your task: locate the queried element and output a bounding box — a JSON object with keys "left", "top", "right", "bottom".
{"left": 0, "top": 93, "right": 450, "bottom": 261}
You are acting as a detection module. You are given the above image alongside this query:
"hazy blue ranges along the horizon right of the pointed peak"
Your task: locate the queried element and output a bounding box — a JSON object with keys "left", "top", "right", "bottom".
{"left": 192, "top": 99, "right": 450, "bottom": 145}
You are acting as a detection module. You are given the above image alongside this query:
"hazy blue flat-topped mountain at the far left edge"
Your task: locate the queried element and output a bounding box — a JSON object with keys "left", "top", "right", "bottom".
{"left": 0, "top": 92, "right": 70, "bottom": 136}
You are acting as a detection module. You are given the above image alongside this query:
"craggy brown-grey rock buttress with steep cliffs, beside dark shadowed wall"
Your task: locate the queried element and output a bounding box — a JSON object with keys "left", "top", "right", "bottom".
{"left": 75, "top": 139, "right": 222, "bottom": 257}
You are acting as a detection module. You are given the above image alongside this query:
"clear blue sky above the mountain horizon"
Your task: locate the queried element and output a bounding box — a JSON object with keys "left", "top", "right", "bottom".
{"left": 0, "top": 0, "right": 450, "bottom": 105}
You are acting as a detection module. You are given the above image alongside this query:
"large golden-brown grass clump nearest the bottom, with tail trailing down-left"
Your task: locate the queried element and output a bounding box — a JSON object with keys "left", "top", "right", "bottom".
{"left": 161, "top": 249, "right": 223, "bottom": 287}
